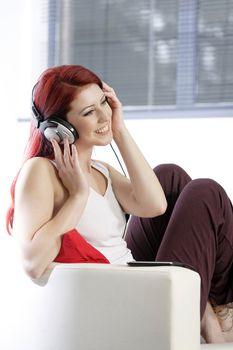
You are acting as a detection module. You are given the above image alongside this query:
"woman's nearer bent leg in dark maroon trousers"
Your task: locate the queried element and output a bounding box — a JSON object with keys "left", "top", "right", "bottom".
{"left": 156, "top": 179, "right": 233, "bottom": 316}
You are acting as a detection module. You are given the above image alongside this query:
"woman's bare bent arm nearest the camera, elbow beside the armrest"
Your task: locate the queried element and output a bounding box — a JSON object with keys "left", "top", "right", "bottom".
{"left": 13, "top": 139, "right": 88, "bottom": 278}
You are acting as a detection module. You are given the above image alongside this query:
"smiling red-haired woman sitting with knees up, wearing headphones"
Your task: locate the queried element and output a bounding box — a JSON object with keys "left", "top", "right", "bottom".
{"left": 7, "top": 65, "right": 233, "bottom": 342}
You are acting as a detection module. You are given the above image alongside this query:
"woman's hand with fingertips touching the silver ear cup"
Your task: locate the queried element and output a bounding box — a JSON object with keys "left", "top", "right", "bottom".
{"left": 51, "top": 139, "right": 89, "bottom": 196}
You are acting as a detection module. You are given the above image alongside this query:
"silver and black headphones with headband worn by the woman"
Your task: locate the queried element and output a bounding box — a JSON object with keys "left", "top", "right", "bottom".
{"left": 32, "top": 85, "right": 78, "bottom": 144}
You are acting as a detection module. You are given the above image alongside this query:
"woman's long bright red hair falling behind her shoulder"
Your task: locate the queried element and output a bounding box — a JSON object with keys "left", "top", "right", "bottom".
{"left": 6, "top": 65, "right": 103, "bottom": 234}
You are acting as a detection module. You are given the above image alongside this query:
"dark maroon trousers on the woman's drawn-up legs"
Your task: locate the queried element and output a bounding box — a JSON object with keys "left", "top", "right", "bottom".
{"left": 126, "top": 164, "right": 233, "bottom": 317}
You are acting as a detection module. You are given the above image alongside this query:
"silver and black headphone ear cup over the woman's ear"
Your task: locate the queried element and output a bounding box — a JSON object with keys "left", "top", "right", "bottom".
{"left": 39, "top": 117, "right": 78, "bottom": 144}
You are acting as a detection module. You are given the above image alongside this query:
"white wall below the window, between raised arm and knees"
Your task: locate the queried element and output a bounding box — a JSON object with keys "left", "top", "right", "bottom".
{"left": 96, "top": 113, "right": 233, "bottom": 199}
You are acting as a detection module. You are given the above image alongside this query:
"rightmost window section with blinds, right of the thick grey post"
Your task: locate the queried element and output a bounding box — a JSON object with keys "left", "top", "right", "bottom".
{"left": 196, "top": 0, "right": 233, "bottom": 104}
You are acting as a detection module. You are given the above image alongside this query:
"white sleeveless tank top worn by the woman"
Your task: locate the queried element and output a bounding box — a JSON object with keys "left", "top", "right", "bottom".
{"left": 76, "top": 161, "right": 133, "bottom": 264}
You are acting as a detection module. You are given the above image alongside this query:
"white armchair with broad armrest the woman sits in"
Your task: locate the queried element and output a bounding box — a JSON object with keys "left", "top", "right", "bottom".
{"left": 0, "top": 264, "right": 233, "bottom": 350}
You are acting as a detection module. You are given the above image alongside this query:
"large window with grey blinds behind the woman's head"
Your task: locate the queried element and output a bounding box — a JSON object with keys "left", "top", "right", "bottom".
{"left": 33, "top": 0, "right": 233, "bottom": 116}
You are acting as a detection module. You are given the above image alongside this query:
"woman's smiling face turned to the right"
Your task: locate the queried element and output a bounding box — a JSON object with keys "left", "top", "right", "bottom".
{"left": 67, "top": 84, "right": 113, "bottom": 146}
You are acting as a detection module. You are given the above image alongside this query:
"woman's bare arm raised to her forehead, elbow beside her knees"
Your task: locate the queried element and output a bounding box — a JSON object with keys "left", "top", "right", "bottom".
{"left": 104, "top": 84, "right": 167, "bottom": 217}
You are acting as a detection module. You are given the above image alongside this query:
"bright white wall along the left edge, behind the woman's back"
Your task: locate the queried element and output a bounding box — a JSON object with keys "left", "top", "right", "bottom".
{"left": 0, "top": 0, "right": 31, "bottom": 258}
